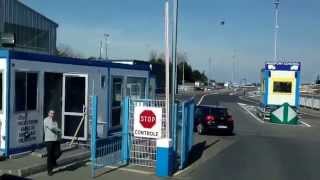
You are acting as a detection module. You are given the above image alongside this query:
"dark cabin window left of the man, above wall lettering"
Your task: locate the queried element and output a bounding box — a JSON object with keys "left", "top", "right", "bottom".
{"left": 15, "top": 72, "right": 38, "bottom": 111}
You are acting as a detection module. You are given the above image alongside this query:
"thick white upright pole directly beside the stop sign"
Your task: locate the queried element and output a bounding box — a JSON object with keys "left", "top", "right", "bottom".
{"left": 164, "top": 0, "right": 170, "bottom": 138}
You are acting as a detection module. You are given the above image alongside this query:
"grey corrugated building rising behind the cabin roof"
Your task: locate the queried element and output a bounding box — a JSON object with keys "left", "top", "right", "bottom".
{"left": 0, "top": 0, "right": 58, "bottom": 55}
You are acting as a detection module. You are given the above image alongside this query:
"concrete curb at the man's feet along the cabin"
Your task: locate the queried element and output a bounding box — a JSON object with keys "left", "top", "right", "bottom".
{"left": 17, "top": 152, "right": 90, "bottom": 177}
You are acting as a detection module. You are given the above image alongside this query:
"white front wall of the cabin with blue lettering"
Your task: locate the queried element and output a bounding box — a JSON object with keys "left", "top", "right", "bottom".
{"left": 10, "top": 60, "right": 108, "bottom": 148}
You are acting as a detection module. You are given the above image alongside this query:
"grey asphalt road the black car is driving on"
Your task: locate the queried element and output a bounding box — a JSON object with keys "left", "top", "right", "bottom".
{"left": 181, "top": 95, "right": 320, "bottom": 180}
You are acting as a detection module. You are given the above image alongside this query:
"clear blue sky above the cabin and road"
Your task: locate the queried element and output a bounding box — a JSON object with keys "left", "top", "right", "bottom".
{"left": 22, "top": 0, "right": 320, "bottom": 82}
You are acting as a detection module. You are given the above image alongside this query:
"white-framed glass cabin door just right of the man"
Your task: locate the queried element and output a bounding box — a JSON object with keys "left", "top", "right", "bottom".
{"left": 62, "top": 74, "right": 88, "bottom": 141}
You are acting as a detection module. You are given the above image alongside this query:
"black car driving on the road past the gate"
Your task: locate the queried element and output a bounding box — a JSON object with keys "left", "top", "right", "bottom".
{"left": 194, "top": 105, "right": 233, "bottom": 134}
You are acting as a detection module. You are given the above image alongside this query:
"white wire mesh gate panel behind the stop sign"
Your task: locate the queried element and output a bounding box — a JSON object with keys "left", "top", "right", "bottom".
{"left": 128, "top": 99, "right": 167, "bottom": 167}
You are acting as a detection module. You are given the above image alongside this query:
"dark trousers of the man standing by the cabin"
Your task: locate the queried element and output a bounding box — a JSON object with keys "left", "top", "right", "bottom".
{"left": 46, "top": 141, "right": 60, "bottom": 172}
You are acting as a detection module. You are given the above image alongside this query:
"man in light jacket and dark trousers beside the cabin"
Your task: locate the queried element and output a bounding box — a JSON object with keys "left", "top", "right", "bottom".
{"left": 43, "top": 110, "right": 61, "bottom": 176}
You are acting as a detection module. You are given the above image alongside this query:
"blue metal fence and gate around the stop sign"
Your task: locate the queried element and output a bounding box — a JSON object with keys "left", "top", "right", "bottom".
{"left": 89, "top": 96, "right": 195, "bottom": 177}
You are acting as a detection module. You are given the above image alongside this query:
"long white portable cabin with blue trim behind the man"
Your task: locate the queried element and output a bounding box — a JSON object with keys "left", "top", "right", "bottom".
{"left": 0, "top": 50, "right": 150, "bottom": 156}
